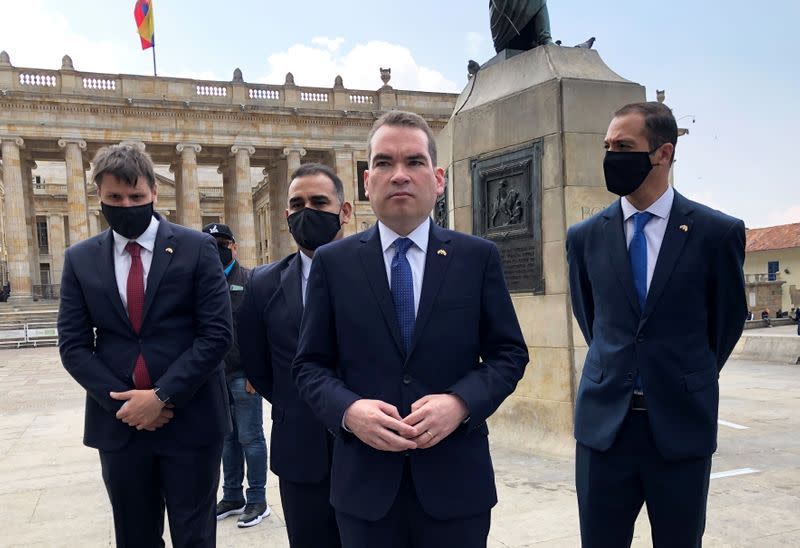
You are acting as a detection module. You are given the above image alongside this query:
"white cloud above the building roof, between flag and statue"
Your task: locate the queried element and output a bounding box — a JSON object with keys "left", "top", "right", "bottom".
{"left": 258, "top": 37, "right": 460, "bottom": 92}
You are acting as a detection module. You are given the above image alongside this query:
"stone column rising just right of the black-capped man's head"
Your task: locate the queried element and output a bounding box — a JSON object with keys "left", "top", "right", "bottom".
{"left": 231, "top": 145, "right": 256, "bottom": 267}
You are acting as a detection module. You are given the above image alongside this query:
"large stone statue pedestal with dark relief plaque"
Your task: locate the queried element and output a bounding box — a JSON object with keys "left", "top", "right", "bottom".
{"left": 438, "top": 45, "right": 645, "bottom": 454}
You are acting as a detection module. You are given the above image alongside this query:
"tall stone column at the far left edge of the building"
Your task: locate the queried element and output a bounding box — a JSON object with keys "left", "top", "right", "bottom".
{"left": 0, "top": 137, "right": 32, "bottom": 302}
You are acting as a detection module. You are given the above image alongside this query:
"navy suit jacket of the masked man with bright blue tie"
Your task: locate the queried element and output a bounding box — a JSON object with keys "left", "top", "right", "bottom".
{"left": 567, "top": 192, "right": 747, "bottom": 460}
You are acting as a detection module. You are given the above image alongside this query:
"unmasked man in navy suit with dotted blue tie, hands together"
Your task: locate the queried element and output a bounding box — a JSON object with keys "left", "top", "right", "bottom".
{"left": 292, "top": 111, "right": 528, "bottom": 548}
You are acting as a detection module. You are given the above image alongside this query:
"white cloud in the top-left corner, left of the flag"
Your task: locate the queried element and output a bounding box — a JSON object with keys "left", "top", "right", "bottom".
{"left": 0, "top": 0, "right": 130, "bottom": 72}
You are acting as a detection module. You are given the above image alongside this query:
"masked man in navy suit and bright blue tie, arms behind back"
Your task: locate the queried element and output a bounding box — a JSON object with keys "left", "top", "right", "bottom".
{"left": 567, "top": 103, "right": 747, "bottom": 547}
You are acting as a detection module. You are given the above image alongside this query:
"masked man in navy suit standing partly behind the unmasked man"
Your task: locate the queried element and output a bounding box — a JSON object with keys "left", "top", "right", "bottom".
{"left": 239, "top": 163, "right": 352, "bottom": 548}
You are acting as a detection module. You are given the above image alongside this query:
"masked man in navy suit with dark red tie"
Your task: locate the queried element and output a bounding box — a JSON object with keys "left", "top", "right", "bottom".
{"left": 58, "top": 145, "right": 233, "bottom": 548}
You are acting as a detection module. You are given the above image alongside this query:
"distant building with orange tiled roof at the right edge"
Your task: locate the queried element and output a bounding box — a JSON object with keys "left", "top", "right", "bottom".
{"left": 744, "top": 223, "right": 800, "bottom": 318}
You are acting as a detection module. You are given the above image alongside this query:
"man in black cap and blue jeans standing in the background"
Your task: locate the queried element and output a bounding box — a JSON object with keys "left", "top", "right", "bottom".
{"left": 203, "top": 223, "right": 270, "bottom": 527}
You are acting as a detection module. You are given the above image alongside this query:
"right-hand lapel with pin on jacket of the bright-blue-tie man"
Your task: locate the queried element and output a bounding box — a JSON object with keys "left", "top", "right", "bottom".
{"left": 642, "top": 192, "right": 693, "bottom": 322}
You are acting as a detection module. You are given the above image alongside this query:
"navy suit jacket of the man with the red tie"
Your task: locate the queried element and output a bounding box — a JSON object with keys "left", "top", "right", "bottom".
{"left": 58, "top": 217, "right": 233, "bottom": 451}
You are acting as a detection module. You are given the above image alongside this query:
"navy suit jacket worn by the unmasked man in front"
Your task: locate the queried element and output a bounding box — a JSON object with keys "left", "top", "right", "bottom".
{"left": 293, "top": 224, "right": 528, "bottom": 520}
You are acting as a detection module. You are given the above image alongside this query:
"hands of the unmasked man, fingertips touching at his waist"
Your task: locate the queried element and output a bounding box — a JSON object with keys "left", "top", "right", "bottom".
{"left": 344, "top": 394, "right": 469, "bottom": 452}
